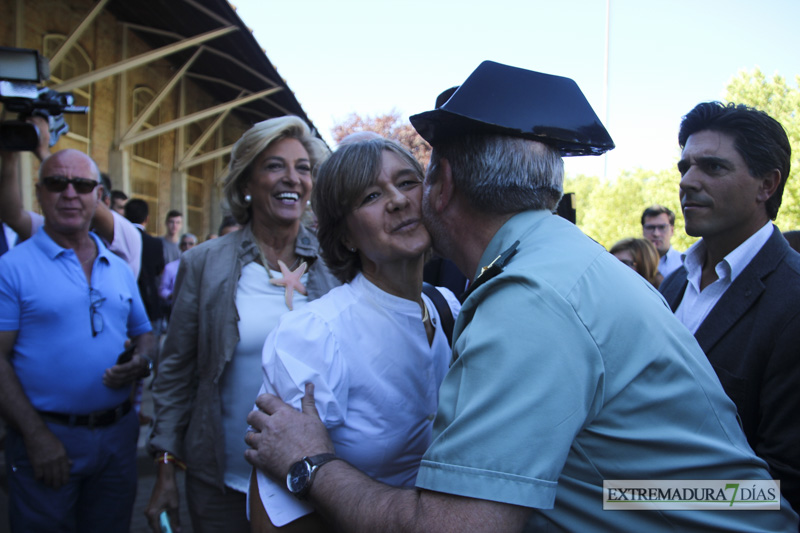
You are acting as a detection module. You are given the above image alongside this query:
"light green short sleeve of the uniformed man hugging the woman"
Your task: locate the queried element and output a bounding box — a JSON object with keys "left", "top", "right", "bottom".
{"left": 417, "top": 276, "right": 603, "bottom": 509}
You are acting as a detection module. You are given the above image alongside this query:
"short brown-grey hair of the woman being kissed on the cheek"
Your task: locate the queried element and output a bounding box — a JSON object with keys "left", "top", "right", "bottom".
{"left": 311, "top": 138, "right": 423, "bottom": 283}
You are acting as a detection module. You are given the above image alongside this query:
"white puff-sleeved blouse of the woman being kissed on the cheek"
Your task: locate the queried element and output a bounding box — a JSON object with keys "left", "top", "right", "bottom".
{"left": 253, "top": 274, "right": 461, "bottom": 527}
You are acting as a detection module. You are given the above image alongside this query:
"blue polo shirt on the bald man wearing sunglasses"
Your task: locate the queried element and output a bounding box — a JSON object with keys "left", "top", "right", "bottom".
{"left": 0, "top": 228, "right": 150, "bottom": 414}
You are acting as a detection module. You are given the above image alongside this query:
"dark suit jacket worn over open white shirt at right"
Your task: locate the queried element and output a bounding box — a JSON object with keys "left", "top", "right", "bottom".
{"left": 659, "top": 227, "right": 800, "bottom": 511}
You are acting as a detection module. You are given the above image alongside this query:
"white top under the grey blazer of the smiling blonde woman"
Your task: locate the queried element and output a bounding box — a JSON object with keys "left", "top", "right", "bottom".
{"left": 220, "top": 261, "right": 308, "bottom": 492}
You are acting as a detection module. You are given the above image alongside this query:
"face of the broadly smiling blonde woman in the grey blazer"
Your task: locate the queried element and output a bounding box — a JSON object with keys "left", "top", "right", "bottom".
{"left": 244, "top": 138, "right": 312, "bottom": 226}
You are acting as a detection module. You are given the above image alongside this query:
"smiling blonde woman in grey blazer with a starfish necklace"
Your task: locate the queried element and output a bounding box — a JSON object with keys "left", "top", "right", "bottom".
{"left": 146, "top": 116, "right": 339, "bottom": 533}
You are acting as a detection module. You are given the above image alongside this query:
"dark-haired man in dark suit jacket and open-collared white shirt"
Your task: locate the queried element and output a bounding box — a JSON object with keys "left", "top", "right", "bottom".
{"left": 660, "top": 102, "right": 800, "bottom": 510}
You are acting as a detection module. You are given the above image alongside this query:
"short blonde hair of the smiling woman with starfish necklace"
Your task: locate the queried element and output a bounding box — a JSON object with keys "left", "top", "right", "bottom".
{"left": 223, "top": 115, "right": 330, "bottom": 225}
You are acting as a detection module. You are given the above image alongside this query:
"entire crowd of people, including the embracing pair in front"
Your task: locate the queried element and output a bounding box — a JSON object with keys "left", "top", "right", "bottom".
{"left": 0, "top": 62, "right": 800, "bottom": 533}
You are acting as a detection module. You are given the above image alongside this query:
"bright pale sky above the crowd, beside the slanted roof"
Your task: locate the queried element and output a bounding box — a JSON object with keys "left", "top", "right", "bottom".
{"left": 232, "top": 0, "right": 800, "bottom": 179}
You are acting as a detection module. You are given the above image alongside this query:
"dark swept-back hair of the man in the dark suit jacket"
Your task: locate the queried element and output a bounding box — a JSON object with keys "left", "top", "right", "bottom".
{"left": 678, "top": 102, "right": 792, "bottom": 220}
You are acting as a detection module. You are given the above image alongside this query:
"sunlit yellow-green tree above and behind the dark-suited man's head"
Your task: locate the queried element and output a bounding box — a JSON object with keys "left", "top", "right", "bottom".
{"left": 725, "top": 68, "right": 800, "bottom": 231}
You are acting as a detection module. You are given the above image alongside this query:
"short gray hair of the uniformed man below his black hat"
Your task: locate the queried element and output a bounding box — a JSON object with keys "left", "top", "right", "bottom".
{"left": 429, "top": 135, "right": 564, "bottom": 215}
